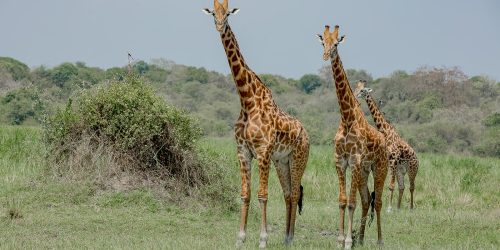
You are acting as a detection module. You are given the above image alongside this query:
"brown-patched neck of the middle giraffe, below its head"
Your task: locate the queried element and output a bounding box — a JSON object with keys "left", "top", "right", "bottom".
{"left": 331, "top": 55, "right": 364, "bottom": 127}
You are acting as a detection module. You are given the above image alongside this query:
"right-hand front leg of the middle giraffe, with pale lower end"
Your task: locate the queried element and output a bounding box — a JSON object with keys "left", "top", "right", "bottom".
{"left": 344, "top": 156, "right": 361, "bottom": 249}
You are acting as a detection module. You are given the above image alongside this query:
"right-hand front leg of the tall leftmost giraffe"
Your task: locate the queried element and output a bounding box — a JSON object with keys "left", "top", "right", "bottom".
{"left": 258, "top": 149, "right": 270, "bottom": 248}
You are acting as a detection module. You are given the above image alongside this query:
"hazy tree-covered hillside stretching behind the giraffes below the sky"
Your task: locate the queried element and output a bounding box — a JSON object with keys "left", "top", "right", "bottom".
{"left": 0, "top": 57, "right": 500, "bottom": 157}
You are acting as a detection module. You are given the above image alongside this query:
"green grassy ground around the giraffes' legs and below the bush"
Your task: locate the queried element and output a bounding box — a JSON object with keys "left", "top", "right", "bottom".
{"left": 0, "top": 127, "right": 500, "bottom": 249}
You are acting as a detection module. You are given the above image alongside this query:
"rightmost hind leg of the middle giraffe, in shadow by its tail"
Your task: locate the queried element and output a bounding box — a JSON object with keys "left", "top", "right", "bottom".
{"left": 373, "top": 160, "right": 387, "bottom": 245}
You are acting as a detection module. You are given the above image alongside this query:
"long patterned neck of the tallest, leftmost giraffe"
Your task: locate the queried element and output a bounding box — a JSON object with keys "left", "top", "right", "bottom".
{"left": 221, "top": 24, "right": 267, "bottom": 111}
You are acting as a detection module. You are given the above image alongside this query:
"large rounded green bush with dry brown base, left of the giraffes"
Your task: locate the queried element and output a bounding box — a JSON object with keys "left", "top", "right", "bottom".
{"left": 44, "top": 76, "right": 234, "bottom": 209}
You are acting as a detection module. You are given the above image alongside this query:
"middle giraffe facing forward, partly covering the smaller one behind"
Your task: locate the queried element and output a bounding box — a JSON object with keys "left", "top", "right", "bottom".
{"left": 317, "top": 25, "right": 387, "bottom": 249}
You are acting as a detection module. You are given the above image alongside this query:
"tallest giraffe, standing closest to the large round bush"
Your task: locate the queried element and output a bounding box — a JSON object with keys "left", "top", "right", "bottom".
{"left": 204, "top": 0, "right": 309, "bottom": 248}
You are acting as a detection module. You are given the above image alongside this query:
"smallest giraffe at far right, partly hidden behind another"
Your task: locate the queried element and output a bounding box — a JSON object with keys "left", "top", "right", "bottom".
{"left": 354, "top": 81, "right": 418, "bottom": 212}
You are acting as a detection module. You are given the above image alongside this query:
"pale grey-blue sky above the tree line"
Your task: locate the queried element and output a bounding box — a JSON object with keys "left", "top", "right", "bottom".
{"left": 0, "top": 0, "right": 500, "bottom": 81}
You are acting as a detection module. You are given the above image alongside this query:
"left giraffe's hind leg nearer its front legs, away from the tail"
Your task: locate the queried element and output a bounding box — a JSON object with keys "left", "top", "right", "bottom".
{"left": 274, "top": 159, "right": 292, "bottom": 244}
